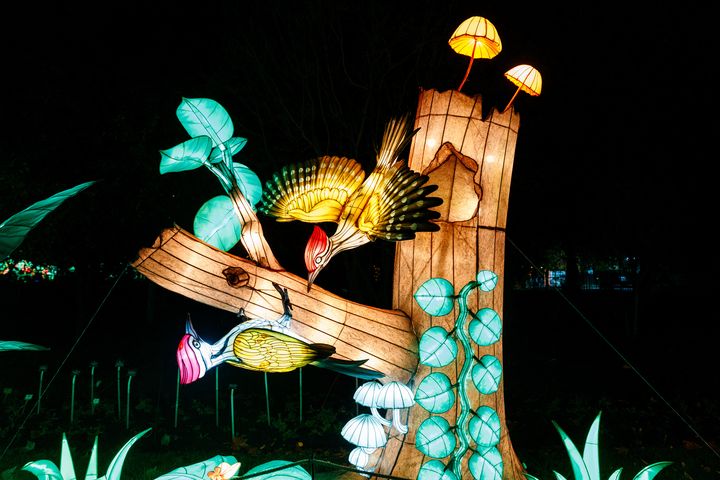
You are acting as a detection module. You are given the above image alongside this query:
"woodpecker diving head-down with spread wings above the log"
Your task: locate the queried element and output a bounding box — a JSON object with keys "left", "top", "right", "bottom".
{"left": 258, "top": 115, "right": 442, "bottom": 291}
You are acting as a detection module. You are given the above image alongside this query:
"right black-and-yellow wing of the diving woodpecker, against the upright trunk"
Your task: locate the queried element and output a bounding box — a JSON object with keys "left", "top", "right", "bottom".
{"left": 357, "top": 163, "right": 442, "bottom": 241}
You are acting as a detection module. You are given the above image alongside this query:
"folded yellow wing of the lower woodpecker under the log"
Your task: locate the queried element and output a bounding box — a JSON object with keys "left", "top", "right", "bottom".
{"left": 228, "top": 328, "right": 335, "bottom": 372}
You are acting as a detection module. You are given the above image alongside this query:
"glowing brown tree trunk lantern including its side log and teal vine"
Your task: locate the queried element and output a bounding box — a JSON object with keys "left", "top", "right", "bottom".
{"left": 133, "top": 90, "right": 525, "bottom": 480}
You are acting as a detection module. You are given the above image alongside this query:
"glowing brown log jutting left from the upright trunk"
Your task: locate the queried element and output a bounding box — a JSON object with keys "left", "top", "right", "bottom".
{"left": 132, "top": 226, "right": 417, "bottom": 383}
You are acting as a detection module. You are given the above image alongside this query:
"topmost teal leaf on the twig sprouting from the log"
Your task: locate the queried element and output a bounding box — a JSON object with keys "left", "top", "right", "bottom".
{"left": 175, "top": 98, "right": 234, "bottom": 147}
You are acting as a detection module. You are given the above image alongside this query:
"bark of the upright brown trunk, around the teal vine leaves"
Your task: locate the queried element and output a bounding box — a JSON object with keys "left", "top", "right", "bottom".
{"left": 376, "top": 90, "right": 525, "bottom": 480}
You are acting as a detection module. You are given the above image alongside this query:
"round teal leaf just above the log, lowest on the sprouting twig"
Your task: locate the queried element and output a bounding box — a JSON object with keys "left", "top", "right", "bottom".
{"left": 193, "top": 195, "right": 242, "bottom": 251}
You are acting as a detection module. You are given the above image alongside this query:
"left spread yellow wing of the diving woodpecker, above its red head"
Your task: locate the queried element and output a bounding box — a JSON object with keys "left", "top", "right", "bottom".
{"left": 258, "top": 156, "right": 365, "bottom": 223}
